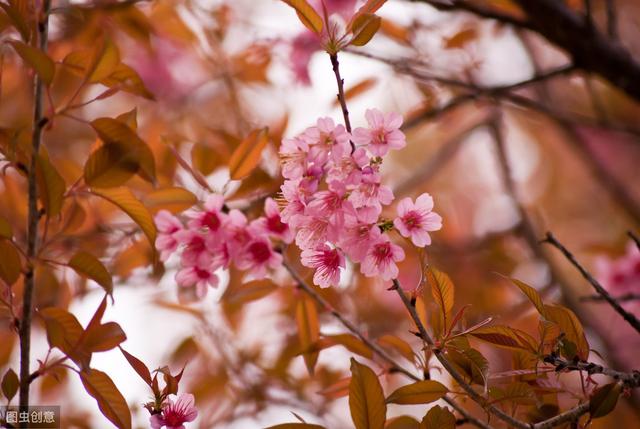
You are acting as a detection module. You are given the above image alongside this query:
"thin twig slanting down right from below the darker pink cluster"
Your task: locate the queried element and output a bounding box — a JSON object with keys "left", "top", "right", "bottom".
{"left": 283, "top": 261, "right": 492, "bottom": 429}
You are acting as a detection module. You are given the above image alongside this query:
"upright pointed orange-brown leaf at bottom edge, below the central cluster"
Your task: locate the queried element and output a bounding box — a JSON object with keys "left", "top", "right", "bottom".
{"left": 349, "top": 358, "right": 387, "bottom": 429}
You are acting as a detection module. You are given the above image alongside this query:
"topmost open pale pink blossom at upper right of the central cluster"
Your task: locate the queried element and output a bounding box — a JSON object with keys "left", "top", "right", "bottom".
{"left": 353, "top": 109, "right": 407, "bottom": 156}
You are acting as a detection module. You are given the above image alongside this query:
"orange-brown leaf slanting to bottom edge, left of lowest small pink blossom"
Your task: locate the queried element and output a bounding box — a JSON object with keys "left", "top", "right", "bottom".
{"left": 80, "top": 369, "right": 131, "bottom": 429}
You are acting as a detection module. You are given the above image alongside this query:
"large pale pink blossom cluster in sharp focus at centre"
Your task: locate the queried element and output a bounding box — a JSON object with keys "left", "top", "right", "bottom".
{"left": 280, "top": 109, "right": 442, "bottom": 287}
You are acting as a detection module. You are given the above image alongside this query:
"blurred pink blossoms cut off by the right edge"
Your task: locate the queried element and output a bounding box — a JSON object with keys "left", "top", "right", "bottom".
{"left": 596, "top": 241, "right": 640, "bottom": 315}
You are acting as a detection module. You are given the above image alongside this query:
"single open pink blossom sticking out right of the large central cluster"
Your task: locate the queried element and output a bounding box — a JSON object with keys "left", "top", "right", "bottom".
{"left": 393, "top": 193, "right": 442, "bottom": 247}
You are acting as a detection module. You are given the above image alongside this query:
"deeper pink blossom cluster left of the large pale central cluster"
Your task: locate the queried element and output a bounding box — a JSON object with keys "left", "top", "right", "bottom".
{"left": 155, "top": 194, "right": 293, "bottom": 299}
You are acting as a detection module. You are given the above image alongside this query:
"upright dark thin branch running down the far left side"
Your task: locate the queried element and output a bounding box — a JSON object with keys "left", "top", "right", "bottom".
{"left": 19, "top": 0, "right": 51, "bottom": 416}
